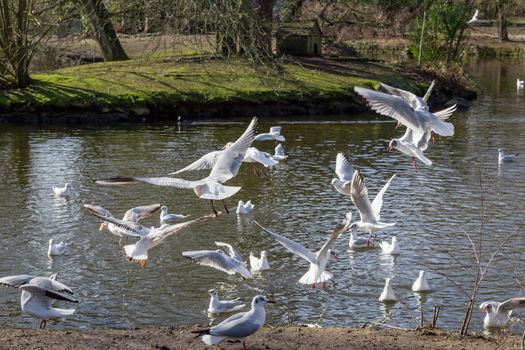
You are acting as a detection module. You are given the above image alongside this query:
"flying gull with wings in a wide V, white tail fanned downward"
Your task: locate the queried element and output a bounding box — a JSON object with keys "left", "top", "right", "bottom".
{"left": 252, "top": 213, "right": 352, "bottom": 288}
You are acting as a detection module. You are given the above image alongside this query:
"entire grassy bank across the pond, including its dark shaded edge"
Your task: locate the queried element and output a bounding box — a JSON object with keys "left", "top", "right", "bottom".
{"left": 0, "top": 57, "right": 470, "bottom": 121}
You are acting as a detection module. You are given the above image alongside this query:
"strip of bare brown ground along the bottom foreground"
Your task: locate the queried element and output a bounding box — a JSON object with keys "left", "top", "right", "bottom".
{"left": 0, "top": 326, "right": 520, "bottom": 350}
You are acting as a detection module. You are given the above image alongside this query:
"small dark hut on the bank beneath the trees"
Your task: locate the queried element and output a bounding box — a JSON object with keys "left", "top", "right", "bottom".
{"left": 275, "top": 21, "right": 323, "bottom": 56}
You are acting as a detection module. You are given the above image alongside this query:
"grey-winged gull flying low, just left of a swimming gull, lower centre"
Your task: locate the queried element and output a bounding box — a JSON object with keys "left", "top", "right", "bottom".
{"left": 182, "top": 247, "right": 252, "bottom": 278}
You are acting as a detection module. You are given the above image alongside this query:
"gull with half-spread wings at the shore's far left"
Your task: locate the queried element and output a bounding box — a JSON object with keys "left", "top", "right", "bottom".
{"left": 0, "top": 275, "right": 78, "bottom": 329}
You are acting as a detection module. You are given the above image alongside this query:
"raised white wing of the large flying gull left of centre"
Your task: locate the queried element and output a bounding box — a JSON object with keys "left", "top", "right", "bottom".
{"left": 207, "top": 117, "right": 257, "bottom": 183}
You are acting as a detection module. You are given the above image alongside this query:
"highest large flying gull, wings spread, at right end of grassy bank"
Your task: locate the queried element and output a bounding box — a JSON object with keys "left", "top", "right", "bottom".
{"left": 354, "top": 84, "right": 455, "bottom": 140}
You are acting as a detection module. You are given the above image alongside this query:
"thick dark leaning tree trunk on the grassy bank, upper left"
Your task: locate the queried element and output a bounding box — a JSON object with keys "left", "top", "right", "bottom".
{"left": 79, "top": 0, "right": 128, "bottom": 61}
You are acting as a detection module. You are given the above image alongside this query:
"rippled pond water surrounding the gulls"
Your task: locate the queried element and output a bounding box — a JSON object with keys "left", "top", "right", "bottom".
{"left": 0, "top": 58, "right": 525, "bottom": 330}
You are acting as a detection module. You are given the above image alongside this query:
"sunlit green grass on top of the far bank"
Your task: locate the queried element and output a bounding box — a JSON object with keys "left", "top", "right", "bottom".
{"left": 0, "top": 57, "right": 413, "bottom": 111}
